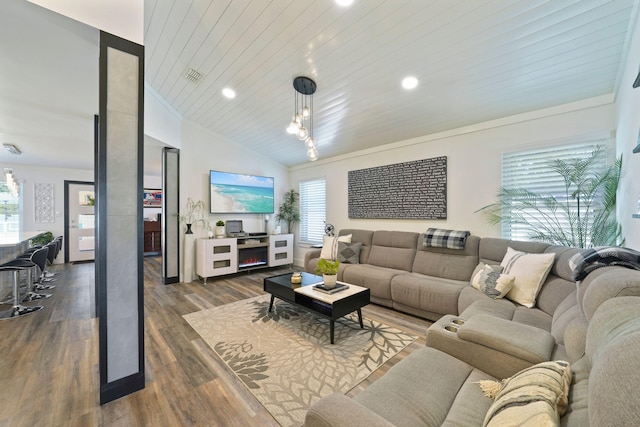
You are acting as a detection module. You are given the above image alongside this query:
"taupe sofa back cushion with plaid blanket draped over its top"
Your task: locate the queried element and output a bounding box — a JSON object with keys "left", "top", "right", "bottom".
{"left": 411, "top": 236, "right": 480, "bottom": 281}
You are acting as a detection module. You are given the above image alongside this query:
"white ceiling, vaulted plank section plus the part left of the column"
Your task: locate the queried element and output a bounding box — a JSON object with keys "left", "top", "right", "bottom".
{"left": 0, "top": 0, "right": 638, "bottom": 172}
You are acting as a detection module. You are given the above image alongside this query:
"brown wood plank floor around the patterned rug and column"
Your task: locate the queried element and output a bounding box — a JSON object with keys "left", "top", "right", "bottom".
{"left": 0, "top": 258, "right": 430, "bottom": 427}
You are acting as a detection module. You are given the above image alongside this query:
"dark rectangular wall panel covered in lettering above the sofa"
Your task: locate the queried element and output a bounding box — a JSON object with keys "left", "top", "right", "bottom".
{"left": 348, "top": 156, "right": 447, "bottom": 219}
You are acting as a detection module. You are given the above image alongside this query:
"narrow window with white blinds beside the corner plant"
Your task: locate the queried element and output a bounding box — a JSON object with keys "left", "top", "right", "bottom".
{"left": 300, "top": 178, "right": 327, "bottom": 245}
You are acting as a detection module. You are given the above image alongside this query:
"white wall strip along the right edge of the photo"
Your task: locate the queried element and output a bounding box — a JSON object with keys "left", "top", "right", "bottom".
{"left": 616, "top": 13, "right": 640, "bottom": 250}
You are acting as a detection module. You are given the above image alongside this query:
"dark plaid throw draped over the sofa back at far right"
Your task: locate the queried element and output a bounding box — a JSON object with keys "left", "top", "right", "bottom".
{"left": 569, "top": 246, "right": 640, "bottom": 282}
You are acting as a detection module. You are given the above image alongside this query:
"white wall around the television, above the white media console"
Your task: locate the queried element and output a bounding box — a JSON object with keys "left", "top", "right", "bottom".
{"left": 180, "top": 120, "right": 289, "bottom": 236}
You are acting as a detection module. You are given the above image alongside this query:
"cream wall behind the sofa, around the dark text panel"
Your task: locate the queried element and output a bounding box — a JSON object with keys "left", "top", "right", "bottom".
{"left": 290, "top": 97, "right": 615, "bottom": 265}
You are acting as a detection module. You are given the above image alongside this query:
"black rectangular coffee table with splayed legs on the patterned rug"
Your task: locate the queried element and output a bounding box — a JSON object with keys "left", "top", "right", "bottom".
{"left": 263, "top": 273, "right": 371, "bottom": 344}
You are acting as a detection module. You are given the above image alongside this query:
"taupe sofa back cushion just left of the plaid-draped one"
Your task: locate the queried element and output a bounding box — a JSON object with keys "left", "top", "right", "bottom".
{"left": 367, "top": 231, "right": 418, "bottom": 271}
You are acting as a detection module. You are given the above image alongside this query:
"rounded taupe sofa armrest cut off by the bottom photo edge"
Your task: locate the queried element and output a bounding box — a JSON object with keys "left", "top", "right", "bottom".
{"left": 304, "top": 393, "right": 393, "bottom": 427}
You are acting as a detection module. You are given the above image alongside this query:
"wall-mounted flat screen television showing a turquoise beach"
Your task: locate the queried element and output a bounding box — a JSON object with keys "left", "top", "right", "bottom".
{"left": 209, "top": 170, "right": 273, "bottom": 214}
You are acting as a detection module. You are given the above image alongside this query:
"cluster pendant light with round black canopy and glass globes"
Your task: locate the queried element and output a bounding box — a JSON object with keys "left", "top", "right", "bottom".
{"left": 287, "top": 76, "right": 318, "bottom": 162}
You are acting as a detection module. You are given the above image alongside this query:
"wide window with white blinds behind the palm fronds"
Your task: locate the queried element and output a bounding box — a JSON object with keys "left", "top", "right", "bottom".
{"left": 502, "top": 139, "right": 609, "bottom": 240}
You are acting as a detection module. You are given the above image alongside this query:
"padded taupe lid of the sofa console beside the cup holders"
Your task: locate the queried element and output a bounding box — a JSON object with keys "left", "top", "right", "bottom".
{"left": 458, "top": 314, "right": 555, "bottom": 364}
